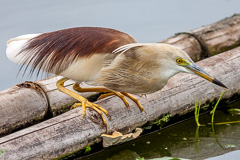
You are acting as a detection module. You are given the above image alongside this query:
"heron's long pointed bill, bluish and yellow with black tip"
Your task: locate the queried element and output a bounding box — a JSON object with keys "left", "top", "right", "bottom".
{"left": 186, "top": 64, "right": 228, "bottom": 89}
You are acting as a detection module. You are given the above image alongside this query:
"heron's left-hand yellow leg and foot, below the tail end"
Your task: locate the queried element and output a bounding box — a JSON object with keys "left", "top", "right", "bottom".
{"left": 56, "top": 78, "right": 108, "bottom": 125}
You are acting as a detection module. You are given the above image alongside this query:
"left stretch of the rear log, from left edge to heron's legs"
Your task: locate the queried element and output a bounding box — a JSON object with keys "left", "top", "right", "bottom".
{"left": 0, "top": 76, "right": 94, "bottom": 136}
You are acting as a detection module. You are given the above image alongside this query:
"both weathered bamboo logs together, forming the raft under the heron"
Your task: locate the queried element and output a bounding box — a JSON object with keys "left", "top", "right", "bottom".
{"left": 0, "top": 15, "right": 240, "bottom": 160}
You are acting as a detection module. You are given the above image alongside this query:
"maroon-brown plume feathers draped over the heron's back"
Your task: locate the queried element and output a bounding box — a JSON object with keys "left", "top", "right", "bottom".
{"left": 18, "top": 27, "right": 136, "bottom": 75}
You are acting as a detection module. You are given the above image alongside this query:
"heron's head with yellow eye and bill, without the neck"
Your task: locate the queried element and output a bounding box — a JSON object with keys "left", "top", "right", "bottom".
{"left": 151, "top": 43, "right": 227, "bottom": 89}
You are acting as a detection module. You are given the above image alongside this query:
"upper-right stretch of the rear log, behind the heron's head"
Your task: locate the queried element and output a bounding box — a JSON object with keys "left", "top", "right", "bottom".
{"left": 161, "top": 14, "right": 240, "bottom": 61}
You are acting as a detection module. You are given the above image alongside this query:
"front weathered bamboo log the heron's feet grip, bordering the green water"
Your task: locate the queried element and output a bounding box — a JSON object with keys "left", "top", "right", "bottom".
{"left": 0, "top": 47, "right": 240, "bottom": 160}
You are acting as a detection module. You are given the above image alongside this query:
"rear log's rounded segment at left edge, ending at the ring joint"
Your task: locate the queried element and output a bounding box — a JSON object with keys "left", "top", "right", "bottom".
{"left": 0, "top": 82, "right": 48, "bottom": 135}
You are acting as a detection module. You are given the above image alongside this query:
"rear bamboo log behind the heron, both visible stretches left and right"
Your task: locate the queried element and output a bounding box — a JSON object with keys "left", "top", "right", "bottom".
{"left": 0, "top": 15, "right": 240, "bottom": 135}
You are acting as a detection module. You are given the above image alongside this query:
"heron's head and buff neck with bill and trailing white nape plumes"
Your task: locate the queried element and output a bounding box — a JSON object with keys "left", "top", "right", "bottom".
{"left": 113, "top": 43, "right": 227, "bottom": 89}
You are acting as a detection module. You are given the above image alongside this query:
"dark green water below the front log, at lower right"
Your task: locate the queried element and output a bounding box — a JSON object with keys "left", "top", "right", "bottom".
{"left": 79, "top": 101, "right": 240, "bottom": 160}
